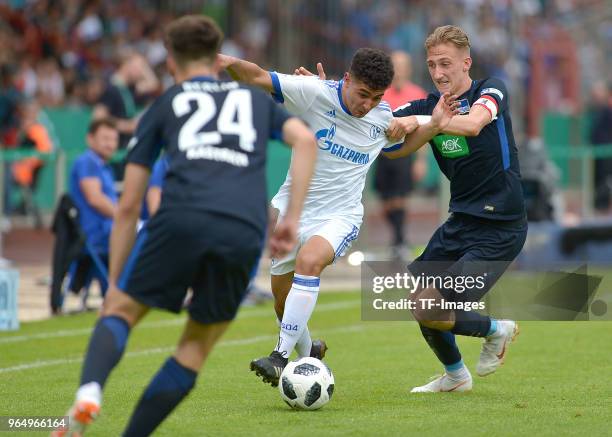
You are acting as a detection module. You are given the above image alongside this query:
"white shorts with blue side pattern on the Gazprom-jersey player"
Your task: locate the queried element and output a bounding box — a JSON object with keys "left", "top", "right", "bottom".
{"left": 270, "top": 217, "right": 359, "bottom": 276}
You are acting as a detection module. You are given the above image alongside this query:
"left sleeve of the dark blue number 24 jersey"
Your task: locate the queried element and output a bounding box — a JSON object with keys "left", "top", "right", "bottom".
{"left": 127, "top": 96, "right": 163, "bottom": 168}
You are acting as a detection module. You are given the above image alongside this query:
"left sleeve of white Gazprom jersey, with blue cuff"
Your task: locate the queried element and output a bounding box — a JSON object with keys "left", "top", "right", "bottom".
{"left": 270, "top": 71, "right": 321, "bottom": 115}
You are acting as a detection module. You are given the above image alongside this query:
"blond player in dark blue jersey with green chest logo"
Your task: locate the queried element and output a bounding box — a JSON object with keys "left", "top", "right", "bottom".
{"left": 310, "top": 26, "right": 527, "bottom": 393}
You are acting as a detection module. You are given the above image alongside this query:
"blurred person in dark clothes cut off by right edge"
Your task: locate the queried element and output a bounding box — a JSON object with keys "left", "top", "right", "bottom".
{"left": 589, "top": 81, "right": 612, "bottom": 211}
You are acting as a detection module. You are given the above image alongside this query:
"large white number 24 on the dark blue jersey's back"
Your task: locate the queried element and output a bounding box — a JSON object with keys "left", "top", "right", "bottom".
{"left": 172, "top": 89, "right": 257, "bottom": 152}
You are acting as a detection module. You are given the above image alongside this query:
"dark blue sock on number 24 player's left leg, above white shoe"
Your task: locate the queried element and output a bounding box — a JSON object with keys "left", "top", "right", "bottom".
{"left": 81, "top": 316, "right": 130, "bottom": 388}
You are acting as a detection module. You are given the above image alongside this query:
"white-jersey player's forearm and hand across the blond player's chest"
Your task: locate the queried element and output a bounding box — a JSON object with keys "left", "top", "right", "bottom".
{"left": 384, "top": 93, "right": 458, "bottom": 158}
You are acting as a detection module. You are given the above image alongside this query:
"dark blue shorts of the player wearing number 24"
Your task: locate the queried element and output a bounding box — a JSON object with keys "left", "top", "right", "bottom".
{"left": 118, "top": 209, "right": 263, "bottom": 323}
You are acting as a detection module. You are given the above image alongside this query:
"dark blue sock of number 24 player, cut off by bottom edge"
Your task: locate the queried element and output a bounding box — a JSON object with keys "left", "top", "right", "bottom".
{"left": 123, "top": 357, "right": 197, "bottom": 436}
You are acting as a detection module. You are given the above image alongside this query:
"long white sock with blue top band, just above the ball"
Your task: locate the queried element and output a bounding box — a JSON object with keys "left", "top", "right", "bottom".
{"left": 274, "top": 273, "right": 320, "bottom": 358}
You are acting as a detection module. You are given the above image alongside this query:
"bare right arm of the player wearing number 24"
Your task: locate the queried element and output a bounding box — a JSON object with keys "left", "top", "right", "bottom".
{"left": 270, "top": 117, "right": 317, "bottom": 258}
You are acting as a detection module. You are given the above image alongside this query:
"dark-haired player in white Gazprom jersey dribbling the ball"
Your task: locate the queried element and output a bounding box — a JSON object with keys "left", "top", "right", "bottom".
{"left": 218, "top": 48, "right": 450, "bottom": 386}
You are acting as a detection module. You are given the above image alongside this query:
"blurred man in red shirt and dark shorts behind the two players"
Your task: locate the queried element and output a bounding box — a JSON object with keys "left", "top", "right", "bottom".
{"left": 374, "top": 51, "right": 427, "bottom": 259}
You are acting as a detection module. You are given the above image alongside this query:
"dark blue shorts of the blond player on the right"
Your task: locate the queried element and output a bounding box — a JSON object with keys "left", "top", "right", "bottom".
{"left": 408, "top": 213, "right": 527, "bottom": 302}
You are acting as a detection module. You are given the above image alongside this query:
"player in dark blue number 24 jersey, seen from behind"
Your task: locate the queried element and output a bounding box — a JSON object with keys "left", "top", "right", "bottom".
{"left": 55, "top": 16, "right": 316, "bottom": 436}
